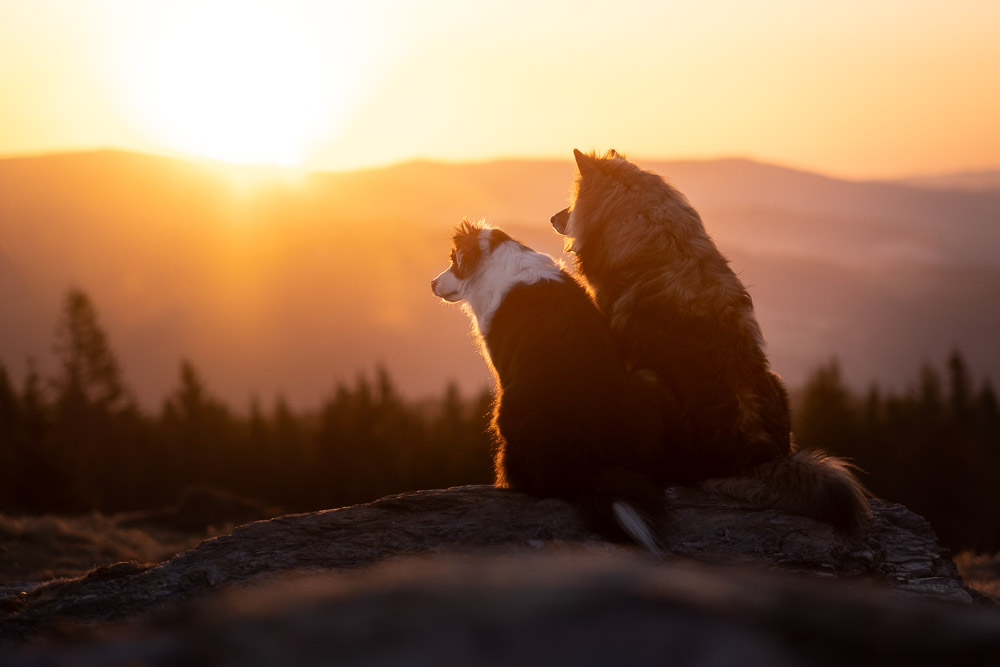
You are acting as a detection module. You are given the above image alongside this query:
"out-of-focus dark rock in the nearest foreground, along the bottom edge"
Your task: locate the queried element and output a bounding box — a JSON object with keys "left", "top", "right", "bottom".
{"left": 7, "top": 547, "right": 1000, "bottom": 667}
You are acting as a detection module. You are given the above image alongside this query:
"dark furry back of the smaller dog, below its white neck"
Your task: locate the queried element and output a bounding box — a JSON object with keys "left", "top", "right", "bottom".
{"left": 485, "top": 276, "right": 662, "bottom": 498}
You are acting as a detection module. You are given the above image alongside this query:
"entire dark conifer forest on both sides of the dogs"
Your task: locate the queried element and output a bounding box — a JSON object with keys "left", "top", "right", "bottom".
{"left": 0, "top": 288, "right": 1000, "bottom": 553}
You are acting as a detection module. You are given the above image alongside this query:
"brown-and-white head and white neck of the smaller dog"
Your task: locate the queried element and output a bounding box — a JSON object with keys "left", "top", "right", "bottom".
{"left": 431, "top": 220, "right": 563, "bottom": 333}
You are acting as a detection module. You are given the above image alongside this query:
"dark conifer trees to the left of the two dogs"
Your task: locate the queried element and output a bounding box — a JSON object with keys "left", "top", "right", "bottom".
{"left": 0, "top": 289, "right": 493, "bottom": 513}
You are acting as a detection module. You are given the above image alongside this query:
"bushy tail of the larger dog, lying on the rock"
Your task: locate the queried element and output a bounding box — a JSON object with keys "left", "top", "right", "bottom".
{"left": 702, "top": 449, "right": 872, "bottom": 533}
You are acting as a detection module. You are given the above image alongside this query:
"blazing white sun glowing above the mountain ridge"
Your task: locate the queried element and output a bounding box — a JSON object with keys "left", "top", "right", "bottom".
{"left": 117, "top": 0, "right": 363, "bottom": 166}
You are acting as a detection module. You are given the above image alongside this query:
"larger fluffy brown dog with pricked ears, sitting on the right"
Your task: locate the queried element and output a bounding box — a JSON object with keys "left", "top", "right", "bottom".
{"left": 552, "top": 151, "right": 870, "bottom": 529}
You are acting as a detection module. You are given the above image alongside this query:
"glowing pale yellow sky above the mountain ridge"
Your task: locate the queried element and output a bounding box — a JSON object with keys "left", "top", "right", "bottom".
{"left": 0, "top": 0, "right": 1000, "bottom": 179}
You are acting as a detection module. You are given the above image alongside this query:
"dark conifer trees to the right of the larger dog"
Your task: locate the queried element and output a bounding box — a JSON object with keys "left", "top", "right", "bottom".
{"left": 793, "top": 351, "right": 1000, "bottom": 553}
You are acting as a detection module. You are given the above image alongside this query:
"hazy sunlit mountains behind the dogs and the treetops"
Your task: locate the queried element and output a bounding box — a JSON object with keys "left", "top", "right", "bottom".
{"left": 0, "top": 152, "right": 1000, "bottom": 407}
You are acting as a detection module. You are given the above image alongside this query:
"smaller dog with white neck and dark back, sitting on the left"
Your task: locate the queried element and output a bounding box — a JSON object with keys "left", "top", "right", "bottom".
{"left": 431, "top": 221, "right": 665, "bottom": 552}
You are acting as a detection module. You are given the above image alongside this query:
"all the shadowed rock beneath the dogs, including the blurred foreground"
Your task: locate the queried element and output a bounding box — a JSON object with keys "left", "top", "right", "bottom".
{"left": 0, "top": 486, "right": 1000, "bottom": 665}
